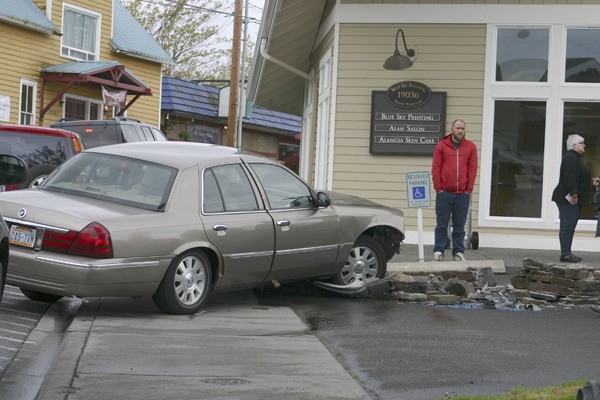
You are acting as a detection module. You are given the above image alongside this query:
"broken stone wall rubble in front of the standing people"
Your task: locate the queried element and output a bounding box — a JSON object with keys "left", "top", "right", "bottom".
{"left": 378, "top": 258, "right": 600, "bottom": 311}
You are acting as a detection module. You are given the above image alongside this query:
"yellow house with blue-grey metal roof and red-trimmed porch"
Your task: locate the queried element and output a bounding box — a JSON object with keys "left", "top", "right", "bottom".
{"left": 0, "top": 0, "right": 173, "bottom": 126}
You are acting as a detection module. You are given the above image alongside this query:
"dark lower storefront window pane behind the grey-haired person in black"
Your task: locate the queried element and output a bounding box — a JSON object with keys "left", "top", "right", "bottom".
{"left": 562, "top": 102, "right": 600, "bottom": 220}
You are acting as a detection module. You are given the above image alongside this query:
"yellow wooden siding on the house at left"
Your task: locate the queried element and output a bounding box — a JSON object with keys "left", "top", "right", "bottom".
{"left": 0, "top": 0, "right": 162, "bottom": 126}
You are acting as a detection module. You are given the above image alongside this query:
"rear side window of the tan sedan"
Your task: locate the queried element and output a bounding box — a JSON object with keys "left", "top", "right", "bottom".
{"left": 202, "top": 164, "right": 258, "bottom": 212}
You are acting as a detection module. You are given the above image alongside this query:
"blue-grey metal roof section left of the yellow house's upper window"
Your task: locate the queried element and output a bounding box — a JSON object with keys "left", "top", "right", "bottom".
{"left": 0, "top": 0, "right": 61, "bottom": 35}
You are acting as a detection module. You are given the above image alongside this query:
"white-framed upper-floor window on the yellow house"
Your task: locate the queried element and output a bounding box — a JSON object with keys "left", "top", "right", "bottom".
{"left": 61, "top": 4, "right": 100, "bottom": 61}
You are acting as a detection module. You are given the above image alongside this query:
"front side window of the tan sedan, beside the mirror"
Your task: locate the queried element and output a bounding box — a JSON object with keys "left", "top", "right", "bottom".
{"left": 251, "top": 163, "right": 313, "bottom": 209}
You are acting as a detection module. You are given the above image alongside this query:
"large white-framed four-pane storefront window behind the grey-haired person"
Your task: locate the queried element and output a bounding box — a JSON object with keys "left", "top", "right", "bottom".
{"left": 480, "top": 25, "right": 600, "bottom": 229}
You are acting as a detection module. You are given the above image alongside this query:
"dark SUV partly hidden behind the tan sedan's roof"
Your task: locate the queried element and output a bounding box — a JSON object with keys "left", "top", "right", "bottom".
{"left": 50, "top": 118, "right": 167, "bottom": 149}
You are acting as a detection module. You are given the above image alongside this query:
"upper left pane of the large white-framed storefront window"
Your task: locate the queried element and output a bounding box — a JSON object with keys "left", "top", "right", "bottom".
{"left": 496, "top": 28, "right": 550, "bottom": 82}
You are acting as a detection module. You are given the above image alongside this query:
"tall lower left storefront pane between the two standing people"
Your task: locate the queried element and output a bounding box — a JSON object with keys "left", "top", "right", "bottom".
{"left": 490, "top": 100, "right": 546, "bottom": 218}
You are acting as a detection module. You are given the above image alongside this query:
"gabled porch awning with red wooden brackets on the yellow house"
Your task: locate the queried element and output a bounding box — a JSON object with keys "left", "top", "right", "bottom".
{"left": 39, "top": 61, "right": 152, "bottom": 125}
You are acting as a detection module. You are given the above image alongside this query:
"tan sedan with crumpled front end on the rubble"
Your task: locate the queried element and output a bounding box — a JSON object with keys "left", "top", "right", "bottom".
{"left": 0, "top": 142, "right": 404, "bottom": 314}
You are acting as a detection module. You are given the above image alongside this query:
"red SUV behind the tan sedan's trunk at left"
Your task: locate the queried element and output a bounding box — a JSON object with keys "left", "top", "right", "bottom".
{"left": 0, "top": 125, "right": 83, "bottom": 192}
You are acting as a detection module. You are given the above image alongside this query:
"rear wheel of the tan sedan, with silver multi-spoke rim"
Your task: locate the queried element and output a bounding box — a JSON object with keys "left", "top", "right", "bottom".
{"left": 152, "top": 250, "right": 212, "bottom": 315}
